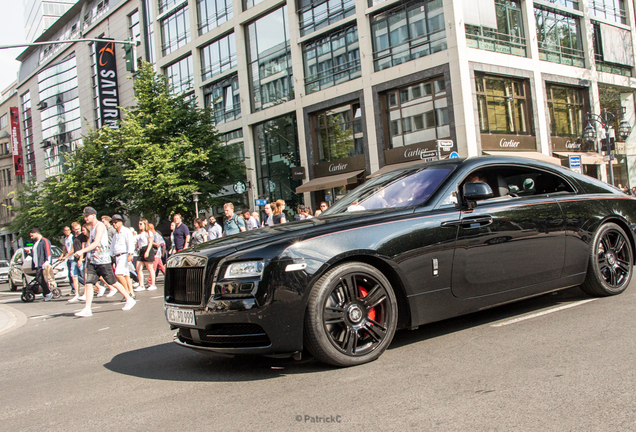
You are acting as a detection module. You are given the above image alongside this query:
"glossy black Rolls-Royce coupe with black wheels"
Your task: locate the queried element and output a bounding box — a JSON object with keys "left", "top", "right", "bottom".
{"left": 165, "top": 157, "right": 636, "bottom": 366}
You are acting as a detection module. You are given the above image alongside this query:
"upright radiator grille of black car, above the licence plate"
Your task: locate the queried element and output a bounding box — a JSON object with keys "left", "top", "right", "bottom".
{"left": 164, "top": 267, "right": 205, "bottom": 306}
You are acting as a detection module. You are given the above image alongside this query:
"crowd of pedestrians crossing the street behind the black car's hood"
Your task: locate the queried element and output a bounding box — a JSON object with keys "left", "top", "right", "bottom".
{"left": 29, "top": 199, "right": 328, "bottom": 308}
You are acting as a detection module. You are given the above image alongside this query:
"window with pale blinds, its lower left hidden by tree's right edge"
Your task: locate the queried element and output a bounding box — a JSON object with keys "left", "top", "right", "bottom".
{"left": 203, "top": 74, "right": 241, "bottom": 124}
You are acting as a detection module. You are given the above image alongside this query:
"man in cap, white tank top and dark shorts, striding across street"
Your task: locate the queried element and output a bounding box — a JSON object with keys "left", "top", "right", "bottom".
{"left": 75, "top": 207, "right": 137, "bottom": 317}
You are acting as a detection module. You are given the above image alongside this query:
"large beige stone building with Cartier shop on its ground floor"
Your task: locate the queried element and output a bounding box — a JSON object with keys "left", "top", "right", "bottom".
{"left": 149, "top": 0, "right": 636, "bottom": 213}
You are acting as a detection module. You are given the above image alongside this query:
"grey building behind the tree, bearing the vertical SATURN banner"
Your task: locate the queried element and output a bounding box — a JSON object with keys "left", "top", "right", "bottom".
{"left": 17, "top": 0, "right": 146, "bottom": 182}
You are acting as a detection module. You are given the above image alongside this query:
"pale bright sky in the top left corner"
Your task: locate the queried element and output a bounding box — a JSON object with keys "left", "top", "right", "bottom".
{"left": 0, "top": 0, "right": 25, "bottom": 91}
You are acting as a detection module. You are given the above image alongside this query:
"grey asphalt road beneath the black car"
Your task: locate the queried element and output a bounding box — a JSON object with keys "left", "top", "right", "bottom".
{"left": 0, "top": 276, "right": 636, "bottom": 432}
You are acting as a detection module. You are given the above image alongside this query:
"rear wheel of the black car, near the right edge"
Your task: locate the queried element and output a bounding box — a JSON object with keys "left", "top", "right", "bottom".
{"left": 581, "top": 223, "right": 634, "bottom": 297}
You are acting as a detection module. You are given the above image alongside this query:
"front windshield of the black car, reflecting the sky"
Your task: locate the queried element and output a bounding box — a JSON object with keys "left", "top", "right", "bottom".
{"left": 324, "top": 166, "right": 454, "bottom": 215}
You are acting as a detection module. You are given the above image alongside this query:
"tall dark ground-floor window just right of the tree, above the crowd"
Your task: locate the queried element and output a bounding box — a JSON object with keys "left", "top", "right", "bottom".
{"left": 254, "top": 114, "right": 303, "bottom": 204}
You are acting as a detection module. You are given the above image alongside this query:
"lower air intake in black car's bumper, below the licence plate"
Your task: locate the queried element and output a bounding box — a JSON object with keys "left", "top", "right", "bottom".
{"left": 179, "top": 324, "right": 271, "bottom": 348}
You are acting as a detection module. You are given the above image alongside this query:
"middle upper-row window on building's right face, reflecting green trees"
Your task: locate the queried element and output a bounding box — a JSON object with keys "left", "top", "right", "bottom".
{"left": 534, "top": 7, "right": 585, "bottom": 67}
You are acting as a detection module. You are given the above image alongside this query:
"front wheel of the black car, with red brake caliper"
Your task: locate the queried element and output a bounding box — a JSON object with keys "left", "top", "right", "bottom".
{"left": 305, "top": 262, "right": 398, "bottom": 366}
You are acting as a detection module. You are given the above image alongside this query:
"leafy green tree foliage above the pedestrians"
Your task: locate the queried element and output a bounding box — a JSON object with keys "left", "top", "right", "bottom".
{"left": 12, "top": 63, "right": 245, "bottom": 241}
